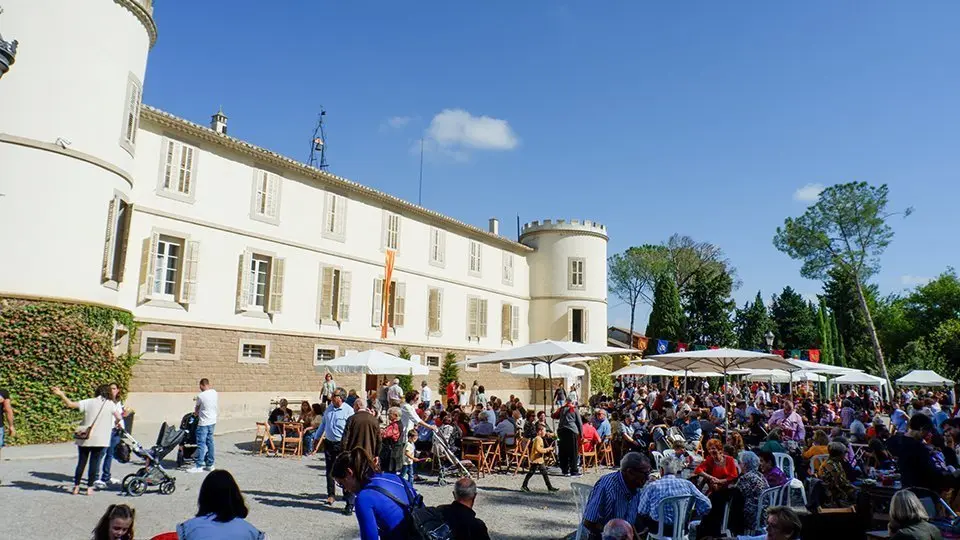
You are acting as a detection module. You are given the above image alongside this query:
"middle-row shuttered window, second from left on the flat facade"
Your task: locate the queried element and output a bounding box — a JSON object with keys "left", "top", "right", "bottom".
{"left": 237, "top": 250, "right": 285, "bottom": 315}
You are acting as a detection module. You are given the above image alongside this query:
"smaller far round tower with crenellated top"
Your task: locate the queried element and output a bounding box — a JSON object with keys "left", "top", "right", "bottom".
{"left": 520, "top": 219, "right": 607, "bottom": 345}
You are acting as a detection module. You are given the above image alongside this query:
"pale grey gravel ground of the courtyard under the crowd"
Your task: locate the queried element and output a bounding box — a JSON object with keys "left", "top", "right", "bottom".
{"left": 0, "top": 433, "right": 608, "bottom": 540}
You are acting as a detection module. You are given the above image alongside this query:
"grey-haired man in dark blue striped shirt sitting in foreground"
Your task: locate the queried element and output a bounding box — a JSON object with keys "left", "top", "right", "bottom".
{"left": 583, "top": 452, "right": 650, "bottom": 540}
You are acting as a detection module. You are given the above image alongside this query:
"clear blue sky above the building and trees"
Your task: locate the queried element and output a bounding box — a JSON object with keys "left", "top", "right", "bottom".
{"left": 144, "top": 0, "right": 960, "bottom": 330}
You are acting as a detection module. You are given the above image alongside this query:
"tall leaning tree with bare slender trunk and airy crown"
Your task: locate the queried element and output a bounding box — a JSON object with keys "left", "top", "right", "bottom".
{"left": 773, "top": 182, "right": 912, "bottom": 384}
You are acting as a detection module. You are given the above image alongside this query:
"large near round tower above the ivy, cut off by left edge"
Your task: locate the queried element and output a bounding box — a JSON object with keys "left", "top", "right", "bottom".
{"left": 0, "top": 0, "right": 157, "bottom": 305}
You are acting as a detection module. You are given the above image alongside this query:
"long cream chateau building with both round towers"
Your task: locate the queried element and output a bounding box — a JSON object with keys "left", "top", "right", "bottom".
{"left": 0, "top": 0, "right": 607, "bottom": 421}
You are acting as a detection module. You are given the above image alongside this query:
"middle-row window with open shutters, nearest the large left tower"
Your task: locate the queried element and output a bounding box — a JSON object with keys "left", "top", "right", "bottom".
{"left": 138, "top": 231, "right": 200, "bottom": 304}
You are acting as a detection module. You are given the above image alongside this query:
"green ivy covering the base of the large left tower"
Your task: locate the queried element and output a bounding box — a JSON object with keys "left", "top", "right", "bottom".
{"left": 0, "top": 299, "right": 136, "bottom": 444}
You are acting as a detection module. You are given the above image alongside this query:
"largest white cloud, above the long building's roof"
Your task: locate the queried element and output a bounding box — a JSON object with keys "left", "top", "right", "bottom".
{"left": 427, "top": 109, "right": 520, "bottom": 151}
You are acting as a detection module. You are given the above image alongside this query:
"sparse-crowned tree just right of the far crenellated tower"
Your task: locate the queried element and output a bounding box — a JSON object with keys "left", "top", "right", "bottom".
{"left": 607, "top": 244, "right": 666, "bottom": 348}
